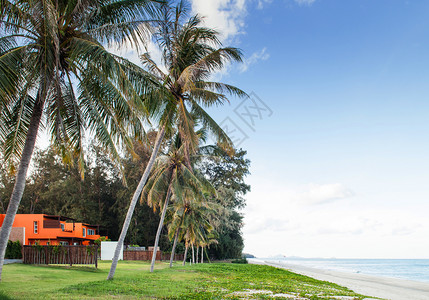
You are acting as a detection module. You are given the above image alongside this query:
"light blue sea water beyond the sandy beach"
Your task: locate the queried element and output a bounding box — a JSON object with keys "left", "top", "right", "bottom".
{"left": 261, "top": 257, "right": 429, "bottom": 282}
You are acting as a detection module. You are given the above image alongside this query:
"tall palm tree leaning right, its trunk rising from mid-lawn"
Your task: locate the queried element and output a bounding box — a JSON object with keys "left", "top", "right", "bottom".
{"left": 107, "top": 1, "right": 247, "bottom": 280}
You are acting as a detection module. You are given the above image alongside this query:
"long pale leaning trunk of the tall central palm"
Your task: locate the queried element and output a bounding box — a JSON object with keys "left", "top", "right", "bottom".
{"left": 107, "top": 125, "right": 165, "bottom": 280}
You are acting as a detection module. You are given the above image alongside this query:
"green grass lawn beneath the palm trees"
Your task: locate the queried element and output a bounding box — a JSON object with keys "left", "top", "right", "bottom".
{"left": 0, "top": 261, "right": 365, "bottom": 300}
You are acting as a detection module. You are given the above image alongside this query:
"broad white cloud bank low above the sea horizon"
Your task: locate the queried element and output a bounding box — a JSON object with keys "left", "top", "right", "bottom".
{"left": 243, "top": 178, "right": 429, "bottom": 258}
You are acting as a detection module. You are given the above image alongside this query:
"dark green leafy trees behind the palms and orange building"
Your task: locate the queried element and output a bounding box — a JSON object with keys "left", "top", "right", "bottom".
{"left": 0, "top": 143, "right": 250, "bottom": 259}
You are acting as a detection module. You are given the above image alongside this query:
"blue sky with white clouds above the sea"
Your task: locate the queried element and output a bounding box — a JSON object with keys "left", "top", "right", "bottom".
{"left": 188, "top": 0, "right": 429, "bottom": 258}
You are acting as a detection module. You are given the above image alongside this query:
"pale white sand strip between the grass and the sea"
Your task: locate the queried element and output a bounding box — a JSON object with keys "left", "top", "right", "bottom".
{"left": 249, "top": 259, "right": 429, "bottom": 300}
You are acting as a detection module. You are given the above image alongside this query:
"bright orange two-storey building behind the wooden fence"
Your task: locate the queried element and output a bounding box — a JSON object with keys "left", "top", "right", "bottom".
{"left": 0, "top": 214, "right": 100, "bottom": 245}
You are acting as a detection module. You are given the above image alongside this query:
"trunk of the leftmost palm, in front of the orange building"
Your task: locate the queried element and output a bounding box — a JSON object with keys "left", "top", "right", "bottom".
{"left": 0, "top": 94, "right": 45, "bottom": 281}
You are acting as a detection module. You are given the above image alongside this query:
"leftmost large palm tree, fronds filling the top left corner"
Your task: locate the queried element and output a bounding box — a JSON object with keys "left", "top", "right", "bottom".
{"left": 0, "top": 0, "right": 160, "bottom": 279}
